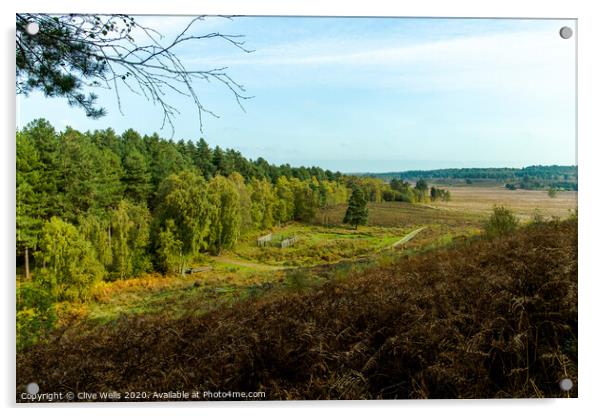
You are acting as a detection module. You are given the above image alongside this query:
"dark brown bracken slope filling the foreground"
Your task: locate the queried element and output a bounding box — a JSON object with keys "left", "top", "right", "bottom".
{"left": 17, "top": 221, "right": 578, "bottom": 400}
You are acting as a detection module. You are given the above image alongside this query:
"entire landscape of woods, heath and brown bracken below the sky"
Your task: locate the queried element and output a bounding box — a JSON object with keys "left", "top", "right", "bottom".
{"left": 16, "top": 120, "right": 577, "bottom": 400}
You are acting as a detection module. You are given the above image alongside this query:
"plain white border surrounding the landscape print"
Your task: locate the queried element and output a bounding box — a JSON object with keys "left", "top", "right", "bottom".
{"left": 0, "top": 0, "right": 602, "bottom": 415}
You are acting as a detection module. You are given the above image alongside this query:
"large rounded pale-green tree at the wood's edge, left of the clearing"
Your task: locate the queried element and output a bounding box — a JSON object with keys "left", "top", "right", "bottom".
{"left": 155, "top": 170, "right": 211, "bottom": 273}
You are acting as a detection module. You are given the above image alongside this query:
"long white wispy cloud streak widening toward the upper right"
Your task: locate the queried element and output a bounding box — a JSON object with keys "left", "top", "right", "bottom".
{"left": 187, "top": 26, "right": 575, "bottom": 98}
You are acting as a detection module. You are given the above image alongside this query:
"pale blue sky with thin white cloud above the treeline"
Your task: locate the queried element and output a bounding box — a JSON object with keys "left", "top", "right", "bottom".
{"left": 17, "top": 16, "right": 576, "bottom": 172}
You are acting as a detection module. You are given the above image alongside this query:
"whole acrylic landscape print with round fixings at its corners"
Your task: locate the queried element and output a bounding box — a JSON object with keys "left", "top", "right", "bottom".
{"left": 15, "top": 13, "right": 578, "bottom": 403}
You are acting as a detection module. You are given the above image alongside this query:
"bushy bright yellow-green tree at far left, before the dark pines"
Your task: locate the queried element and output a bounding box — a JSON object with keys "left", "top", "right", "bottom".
{"left": 34, "top": 217, "right": 104, "bottom": 301}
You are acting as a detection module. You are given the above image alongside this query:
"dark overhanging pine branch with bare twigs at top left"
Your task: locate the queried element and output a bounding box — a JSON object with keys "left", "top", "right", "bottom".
{"left": 16, "top": 13, "right": 251, "bottom": 134}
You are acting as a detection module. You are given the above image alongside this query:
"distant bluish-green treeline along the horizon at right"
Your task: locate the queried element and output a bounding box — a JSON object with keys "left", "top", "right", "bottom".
{"left": 364, "top": 165, "right": 577, "bottom": 190}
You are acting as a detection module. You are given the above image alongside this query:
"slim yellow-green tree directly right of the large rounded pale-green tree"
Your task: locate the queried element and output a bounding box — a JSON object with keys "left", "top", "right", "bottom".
{"left": 207, "top": 175, "right": 241, "bottom": 254}
